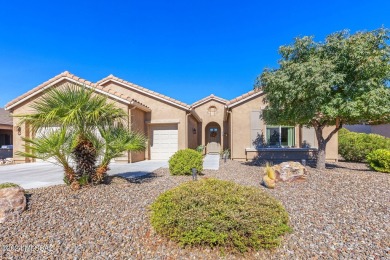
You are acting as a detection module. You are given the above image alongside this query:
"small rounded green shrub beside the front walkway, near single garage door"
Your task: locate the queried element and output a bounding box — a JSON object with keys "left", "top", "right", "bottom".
{"left": 169, "top": 149, "right": 203, "bottom": 175}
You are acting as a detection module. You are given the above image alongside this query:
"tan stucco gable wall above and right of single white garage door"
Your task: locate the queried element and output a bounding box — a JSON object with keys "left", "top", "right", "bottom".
{"left": 103, "top": 82, "right": 187, "bottom": 150}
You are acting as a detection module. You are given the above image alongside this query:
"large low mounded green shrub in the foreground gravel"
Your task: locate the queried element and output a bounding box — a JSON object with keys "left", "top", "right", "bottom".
{"left": 151, "top": 179, "right": 291, "bottom": 252}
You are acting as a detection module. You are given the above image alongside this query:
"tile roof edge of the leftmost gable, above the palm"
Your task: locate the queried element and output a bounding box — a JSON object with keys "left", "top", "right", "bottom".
{"left": 5, "top": 71, "right": 148, "bottom": 109}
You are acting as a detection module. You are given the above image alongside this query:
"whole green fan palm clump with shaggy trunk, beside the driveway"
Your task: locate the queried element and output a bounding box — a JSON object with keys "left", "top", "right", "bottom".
{"left": 18, "top": 84, "right": 146, "bottom": 188}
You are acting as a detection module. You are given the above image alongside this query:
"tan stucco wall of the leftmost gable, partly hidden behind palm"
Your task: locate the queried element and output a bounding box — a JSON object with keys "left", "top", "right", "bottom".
{"left": 10, "top": 79, "right": 128, "bottom": 163}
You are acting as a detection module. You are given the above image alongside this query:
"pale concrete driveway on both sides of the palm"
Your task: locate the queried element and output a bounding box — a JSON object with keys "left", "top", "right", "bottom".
{"left": 0, "top": 161, "right": 168, "bottom": 189}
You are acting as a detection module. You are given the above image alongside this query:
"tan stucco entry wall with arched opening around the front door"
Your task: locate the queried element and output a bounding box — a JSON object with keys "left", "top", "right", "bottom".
{"left": 195, "top": 100, "right": 228, "bottom": 148}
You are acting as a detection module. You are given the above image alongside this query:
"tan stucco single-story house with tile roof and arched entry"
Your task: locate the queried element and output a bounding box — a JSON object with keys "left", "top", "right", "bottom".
{"left": 6, "top": 72, "right": 338, "bottom": 163}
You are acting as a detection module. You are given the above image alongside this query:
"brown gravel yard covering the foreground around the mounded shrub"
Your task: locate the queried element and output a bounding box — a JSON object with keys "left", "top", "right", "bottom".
{"left": 0, "top": 161, "right": 390, "bottom": 259}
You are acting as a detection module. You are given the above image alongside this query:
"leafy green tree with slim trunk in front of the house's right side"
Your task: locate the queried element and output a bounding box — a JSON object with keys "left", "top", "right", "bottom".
{"left": 255, "top": 28, "right": 390, "bottom": 169}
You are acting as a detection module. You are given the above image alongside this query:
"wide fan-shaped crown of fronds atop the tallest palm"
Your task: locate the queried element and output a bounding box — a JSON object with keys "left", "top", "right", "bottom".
{"left": 16, "top": 84, "right": 126, "bottom": 132}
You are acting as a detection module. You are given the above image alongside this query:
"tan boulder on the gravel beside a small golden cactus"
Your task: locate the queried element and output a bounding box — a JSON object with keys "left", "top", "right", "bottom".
{"left": 272, "top": 161, "right": 307, "bottom": 182}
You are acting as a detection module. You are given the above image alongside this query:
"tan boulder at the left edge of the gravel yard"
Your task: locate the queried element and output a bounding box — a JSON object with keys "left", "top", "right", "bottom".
{"left": 0, "top": 186, "right": 26, "bottom": 223}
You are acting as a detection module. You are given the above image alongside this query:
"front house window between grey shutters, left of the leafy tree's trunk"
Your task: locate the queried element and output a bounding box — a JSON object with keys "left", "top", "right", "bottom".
{"left": 267, "top": 126, "right": 295, "bottom": 147}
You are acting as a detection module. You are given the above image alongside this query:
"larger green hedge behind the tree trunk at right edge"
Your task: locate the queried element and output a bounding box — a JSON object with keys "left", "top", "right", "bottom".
{"left": 339, "top": 129, "right": 390, "bottom": 162}
